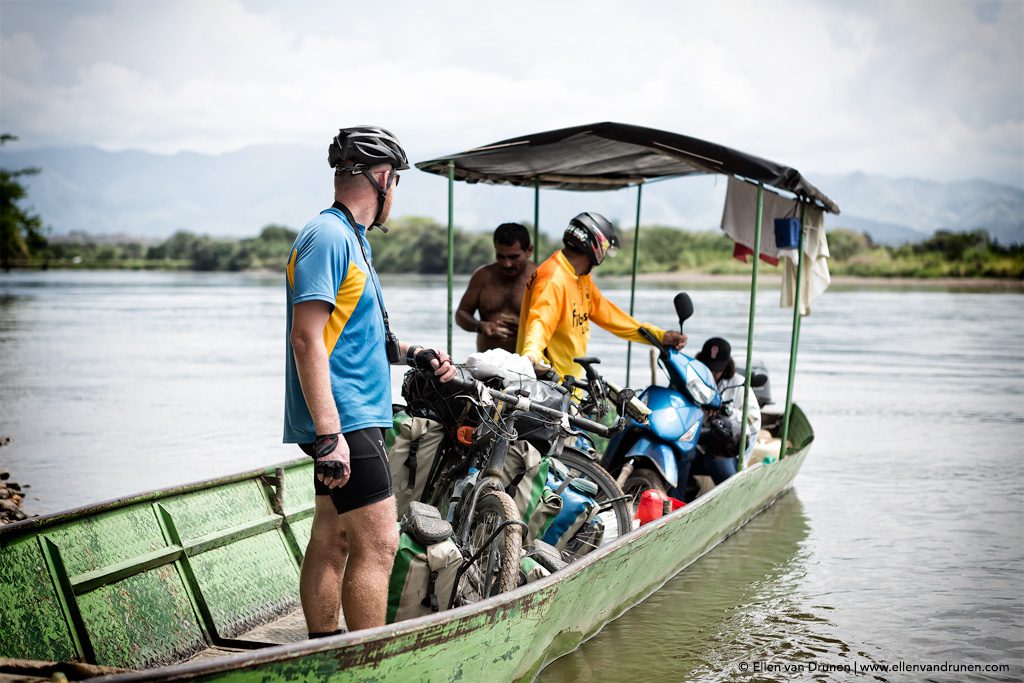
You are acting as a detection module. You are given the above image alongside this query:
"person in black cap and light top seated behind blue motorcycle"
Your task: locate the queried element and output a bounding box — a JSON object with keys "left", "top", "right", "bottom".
{"left": 693, "top": 337, "right": 761, "bottom": 484}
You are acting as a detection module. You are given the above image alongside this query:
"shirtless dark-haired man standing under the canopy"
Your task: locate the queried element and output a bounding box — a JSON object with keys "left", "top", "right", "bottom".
{"left": 455, "top": 223, "right": 537, "bottom": 353}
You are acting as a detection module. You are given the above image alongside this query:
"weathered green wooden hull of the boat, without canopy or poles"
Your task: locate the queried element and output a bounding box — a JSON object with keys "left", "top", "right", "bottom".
{"left": 0, "top": 407, "right": 813, "bottom": 682}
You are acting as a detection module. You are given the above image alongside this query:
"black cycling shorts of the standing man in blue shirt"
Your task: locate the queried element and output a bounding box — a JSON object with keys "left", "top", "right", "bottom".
{"left": 299, "top": 427, "right": 391, "bottom": 515}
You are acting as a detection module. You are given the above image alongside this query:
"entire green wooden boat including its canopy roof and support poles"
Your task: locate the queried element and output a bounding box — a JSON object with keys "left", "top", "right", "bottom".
{"left": 0, "top": 123, "right": 839, "bottom": 682}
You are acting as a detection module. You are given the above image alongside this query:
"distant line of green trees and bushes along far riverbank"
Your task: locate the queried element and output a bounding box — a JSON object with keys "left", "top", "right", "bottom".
{"left": 18, "top": 222, "right": 1024, "bottom": 280}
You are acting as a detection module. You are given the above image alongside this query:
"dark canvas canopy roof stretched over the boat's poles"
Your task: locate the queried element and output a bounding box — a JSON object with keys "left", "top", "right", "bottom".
{"left": 416, "top": 122, "right": 839, "bottom": 213}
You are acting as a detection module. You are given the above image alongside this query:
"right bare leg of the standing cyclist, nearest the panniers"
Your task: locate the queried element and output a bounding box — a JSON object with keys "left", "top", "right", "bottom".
{"left": 337, "top": 497, "right": 398, "bottom": 631}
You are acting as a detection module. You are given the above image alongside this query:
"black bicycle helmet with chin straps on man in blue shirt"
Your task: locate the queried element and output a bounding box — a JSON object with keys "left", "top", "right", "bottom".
{"left": 327, "top": 126, "right": 409, "bottom": 232}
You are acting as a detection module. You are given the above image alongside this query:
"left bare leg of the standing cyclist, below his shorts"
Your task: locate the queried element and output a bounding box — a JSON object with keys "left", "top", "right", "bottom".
{"left": 299, "top": 496, "right": 350, "bottom": 633}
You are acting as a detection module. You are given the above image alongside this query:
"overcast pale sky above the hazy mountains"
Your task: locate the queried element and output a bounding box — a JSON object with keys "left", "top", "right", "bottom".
{"left": 0, "top": 0, "right": 1024, "bottom": 187}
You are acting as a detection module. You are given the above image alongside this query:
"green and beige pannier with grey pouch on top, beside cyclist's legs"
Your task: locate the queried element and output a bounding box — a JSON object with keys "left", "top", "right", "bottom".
{"left": 387, "top": 501, "right": 462, "bottom": 624}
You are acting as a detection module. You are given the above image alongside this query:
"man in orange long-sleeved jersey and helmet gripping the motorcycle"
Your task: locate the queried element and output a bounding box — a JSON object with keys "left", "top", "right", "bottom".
{"left": 516, "top": 212, "right": 686, "bottom": 377}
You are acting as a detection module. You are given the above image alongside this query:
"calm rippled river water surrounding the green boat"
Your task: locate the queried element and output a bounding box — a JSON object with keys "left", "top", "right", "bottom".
{"left": 0, "top": 272, "right": 1024, "bottom": 683}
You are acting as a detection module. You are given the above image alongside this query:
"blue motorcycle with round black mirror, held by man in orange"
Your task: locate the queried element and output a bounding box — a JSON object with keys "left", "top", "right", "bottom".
{"left": 601, "top": 292, "right": 722, "bottom": 501}
